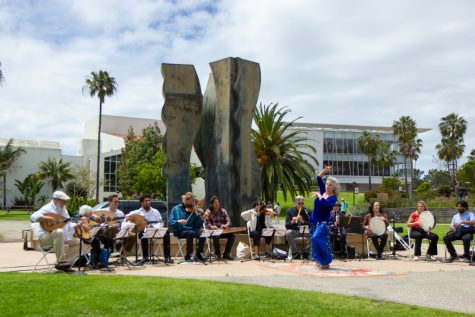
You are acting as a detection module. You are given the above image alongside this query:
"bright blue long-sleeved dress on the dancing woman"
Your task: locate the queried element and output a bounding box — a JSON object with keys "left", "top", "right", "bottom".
{"left": 310, "top": 176, "right": 336, "bottom": 265}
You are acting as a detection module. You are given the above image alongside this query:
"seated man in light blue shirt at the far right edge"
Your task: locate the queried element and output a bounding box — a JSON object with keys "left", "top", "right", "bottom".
{"left": 444, "top": 200, "right": 475, "bottom": 263}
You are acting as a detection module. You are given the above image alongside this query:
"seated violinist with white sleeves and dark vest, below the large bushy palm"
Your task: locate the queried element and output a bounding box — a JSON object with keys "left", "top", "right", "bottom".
{"left": 241, "top": 200, "right": 274, "bottom": 260}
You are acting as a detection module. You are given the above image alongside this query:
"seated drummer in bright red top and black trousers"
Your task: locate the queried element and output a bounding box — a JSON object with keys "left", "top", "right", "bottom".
{"left": 407, "top": 200, "right": 439, "bottom": 261}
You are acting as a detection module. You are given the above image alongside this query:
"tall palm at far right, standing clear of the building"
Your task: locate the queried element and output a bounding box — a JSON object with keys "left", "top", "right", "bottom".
{"left": 436, "top": 113, "right": 467, "bottom": 191}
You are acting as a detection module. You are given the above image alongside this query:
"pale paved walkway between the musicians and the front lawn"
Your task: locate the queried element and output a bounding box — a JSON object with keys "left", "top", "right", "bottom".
{"left": 0, "top": 242, "right": 475, "bottom": 314}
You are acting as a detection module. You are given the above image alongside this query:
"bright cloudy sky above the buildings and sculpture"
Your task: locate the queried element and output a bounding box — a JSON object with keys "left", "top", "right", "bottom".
{"left": 0, "top": 0, "right": 475, "bottom": 172}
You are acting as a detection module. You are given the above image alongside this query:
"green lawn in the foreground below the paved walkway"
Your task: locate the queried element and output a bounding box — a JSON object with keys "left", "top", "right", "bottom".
{"left": 0, "top": 273, "right": 468, "bottom": 317}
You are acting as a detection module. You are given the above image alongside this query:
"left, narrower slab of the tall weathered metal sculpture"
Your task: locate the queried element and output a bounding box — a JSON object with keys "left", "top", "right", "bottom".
{"left": 162, "top": 64, "right": 203, "bottom": 210}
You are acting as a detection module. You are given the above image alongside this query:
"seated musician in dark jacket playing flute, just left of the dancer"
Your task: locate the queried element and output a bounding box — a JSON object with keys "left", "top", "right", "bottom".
{"left": 285, "top": 196, "right": 310, "bottom": 259}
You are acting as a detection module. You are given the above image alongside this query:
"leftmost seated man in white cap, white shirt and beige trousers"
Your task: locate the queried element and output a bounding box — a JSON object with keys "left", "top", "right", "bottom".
{"left": 31, "top": 191, "right": 86, "bottom": 272}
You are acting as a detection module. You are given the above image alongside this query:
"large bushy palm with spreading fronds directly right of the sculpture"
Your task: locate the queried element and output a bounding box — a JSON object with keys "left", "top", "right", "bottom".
{"left": 251, "top": 103, "right": 318, "bottom": 201}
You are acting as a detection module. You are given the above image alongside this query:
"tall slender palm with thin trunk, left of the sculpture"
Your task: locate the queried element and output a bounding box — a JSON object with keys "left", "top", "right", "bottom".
{"left": 82, "top": 70, "right": 117, "bottom": 201}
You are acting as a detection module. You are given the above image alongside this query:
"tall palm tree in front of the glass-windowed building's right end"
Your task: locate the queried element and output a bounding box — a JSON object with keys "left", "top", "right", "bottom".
{"left": 393, "top": 116, "right": 422, "bottom": 196}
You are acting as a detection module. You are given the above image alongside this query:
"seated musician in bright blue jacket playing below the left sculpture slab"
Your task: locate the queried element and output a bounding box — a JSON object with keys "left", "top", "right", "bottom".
{"left": 168, "top": 192, "right": 207, "bottom": 262}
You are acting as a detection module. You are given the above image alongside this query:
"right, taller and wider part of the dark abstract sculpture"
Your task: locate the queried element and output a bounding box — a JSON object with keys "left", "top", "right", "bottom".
{"left": 195, "top": 58, "right": 261, "bottom": 225}
